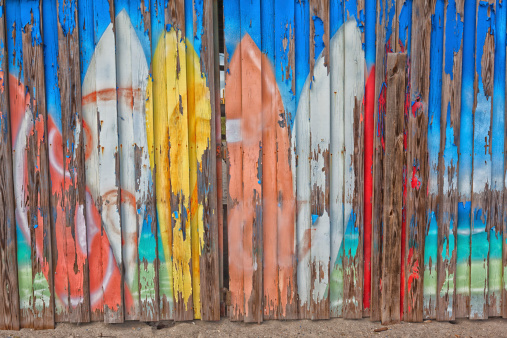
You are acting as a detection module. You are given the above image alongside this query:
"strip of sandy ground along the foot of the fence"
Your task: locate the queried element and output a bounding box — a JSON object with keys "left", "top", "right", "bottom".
{"left": 0, "top": 319, "right": 507, "bottom": 338}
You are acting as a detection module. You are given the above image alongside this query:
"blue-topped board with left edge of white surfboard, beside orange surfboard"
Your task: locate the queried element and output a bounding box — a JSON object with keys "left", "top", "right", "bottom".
{"left": 293, "top": 1, "right": 311, "bottom": 319}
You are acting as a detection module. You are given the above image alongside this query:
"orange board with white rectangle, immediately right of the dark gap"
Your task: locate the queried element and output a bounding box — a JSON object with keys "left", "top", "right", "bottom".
{"left": 224, "top": 0, "right": 245, "bottom": 321}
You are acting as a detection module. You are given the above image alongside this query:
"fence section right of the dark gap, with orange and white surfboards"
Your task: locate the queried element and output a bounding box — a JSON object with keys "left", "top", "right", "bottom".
{"left": 224, "top": 0, "right": 507, "bottom": 323}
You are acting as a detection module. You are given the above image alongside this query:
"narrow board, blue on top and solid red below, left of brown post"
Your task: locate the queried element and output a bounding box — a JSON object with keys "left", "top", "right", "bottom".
{"left": 363, "top": 0, "right": 377, "bottom": 316}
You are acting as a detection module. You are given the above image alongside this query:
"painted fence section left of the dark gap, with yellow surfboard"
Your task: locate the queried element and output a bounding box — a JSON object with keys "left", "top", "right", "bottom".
{"left": 0, "top": 0, "right": 219, "bottom": 328}
